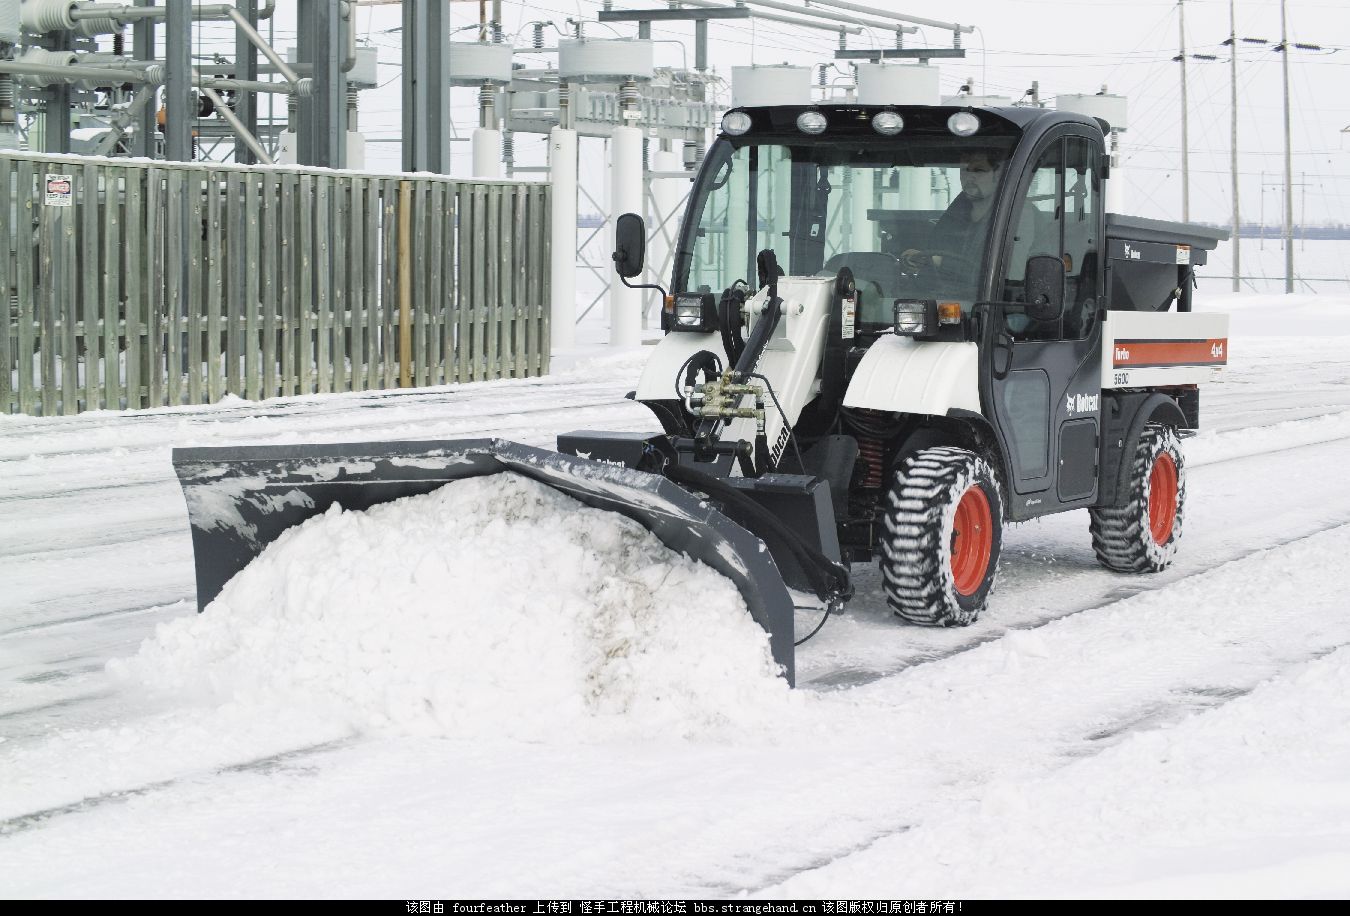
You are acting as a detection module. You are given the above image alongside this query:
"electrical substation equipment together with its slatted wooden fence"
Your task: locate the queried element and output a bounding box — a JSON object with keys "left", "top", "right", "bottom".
{"left": 0, "top": 0, "right": 1126, "bottom": 413}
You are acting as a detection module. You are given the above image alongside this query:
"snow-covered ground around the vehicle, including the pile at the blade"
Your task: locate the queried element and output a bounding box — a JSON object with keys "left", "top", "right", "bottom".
{"left": 0, "top": 293, "right": 1350, "bottom": 898}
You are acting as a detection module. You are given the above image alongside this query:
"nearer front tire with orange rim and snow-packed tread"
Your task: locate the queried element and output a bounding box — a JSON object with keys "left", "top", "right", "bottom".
{"left": 880, "top": 448, "right": 1003, "bottom": 626}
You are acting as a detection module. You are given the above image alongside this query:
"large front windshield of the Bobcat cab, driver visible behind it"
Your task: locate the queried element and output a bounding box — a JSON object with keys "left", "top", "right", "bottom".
{"left": 675, "top": 136, "right": 1015, "bottom": 325}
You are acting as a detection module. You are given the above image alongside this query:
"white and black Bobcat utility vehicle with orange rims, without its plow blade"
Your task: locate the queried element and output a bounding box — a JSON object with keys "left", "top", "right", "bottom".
{"left": 577, "top": 105, "right": 1227, "bottom": 634}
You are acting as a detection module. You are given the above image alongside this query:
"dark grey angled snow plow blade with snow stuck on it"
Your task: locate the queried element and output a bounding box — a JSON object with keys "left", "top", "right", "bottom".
{"left": 173, "top": 438, "right": 794, "bottom": 684}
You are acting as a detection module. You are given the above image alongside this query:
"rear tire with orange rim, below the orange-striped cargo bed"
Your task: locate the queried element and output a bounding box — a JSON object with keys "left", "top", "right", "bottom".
{"left": 1088, "top": 424, "right": 1185, "bottom": 572}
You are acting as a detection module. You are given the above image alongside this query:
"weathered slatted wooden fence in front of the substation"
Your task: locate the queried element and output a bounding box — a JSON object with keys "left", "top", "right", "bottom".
{"left": 0, "top": 151, "right": 549, "bottom": 416}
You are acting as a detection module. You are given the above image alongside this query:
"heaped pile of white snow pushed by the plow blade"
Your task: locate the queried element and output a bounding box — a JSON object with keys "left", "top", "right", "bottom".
{"left": 112, "top": 474, "right": 787, "bottom": 739}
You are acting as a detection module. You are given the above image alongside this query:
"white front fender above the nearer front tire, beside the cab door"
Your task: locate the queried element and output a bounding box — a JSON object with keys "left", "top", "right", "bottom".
{"left": 844, "top": 336, "right": 980, "bottom": 417}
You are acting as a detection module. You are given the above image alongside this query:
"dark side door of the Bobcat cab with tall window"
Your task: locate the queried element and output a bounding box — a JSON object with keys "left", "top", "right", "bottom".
{"left": 981, "top": 135, "right": 1104, "bottom": 518}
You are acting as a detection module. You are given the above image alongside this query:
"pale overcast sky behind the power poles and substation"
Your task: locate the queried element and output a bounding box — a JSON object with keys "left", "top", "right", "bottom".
{"left": 245, "top": 0, "right": 1350, "bottom": 224}
